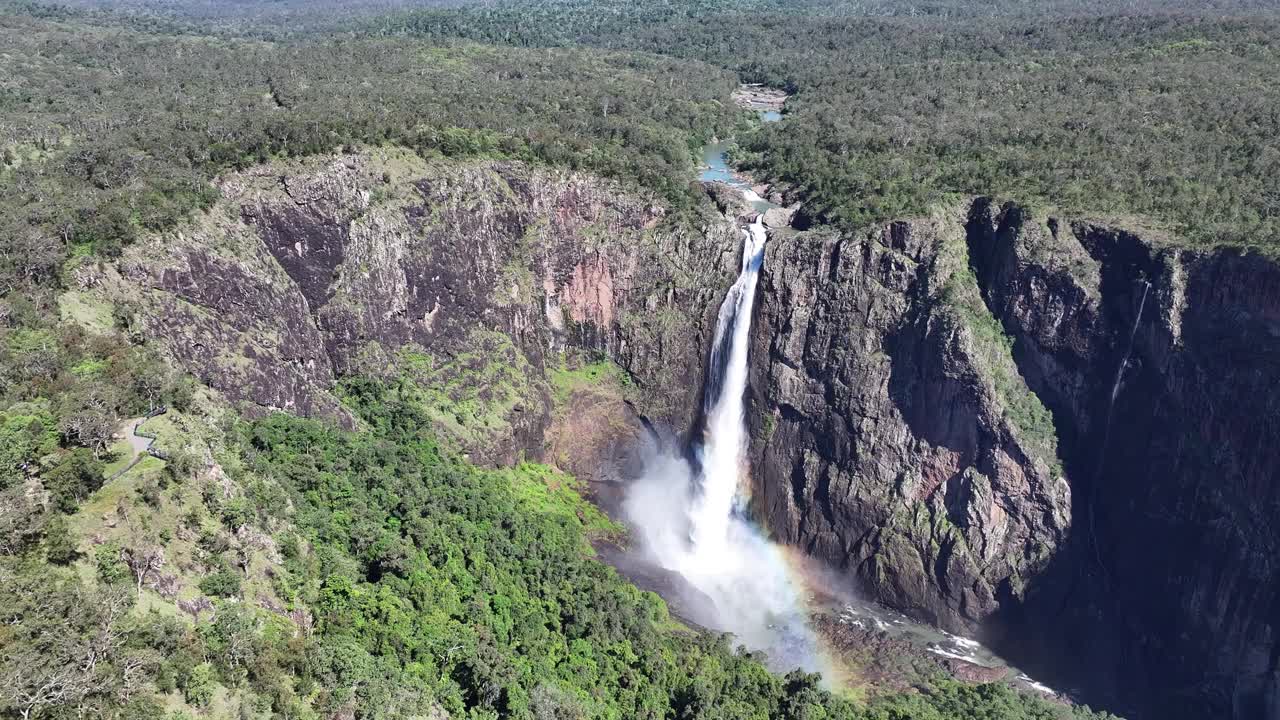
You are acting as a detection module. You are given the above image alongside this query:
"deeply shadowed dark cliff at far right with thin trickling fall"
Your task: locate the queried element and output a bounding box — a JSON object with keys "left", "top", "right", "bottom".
{"left": 969, "top": 202, "right": 1280, "bottom": 719}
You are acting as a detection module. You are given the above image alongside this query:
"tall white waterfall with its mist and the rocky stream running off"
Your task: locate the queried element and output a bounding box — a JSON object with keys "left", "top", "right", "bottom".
{"left": 622, "top": 212, "right": 1059, "bottom": 692}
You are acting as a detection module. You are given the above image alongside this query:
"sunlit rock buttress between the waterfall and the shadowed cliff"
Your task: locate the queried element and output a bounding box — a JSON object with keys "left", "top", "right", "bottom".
{"left": 751, "top": 204, "right": 1071, "bottom": 632}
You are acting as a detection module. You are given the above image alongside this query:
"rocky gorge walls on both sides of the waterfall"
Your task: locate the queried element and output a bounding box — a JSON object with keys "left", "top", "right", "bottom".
{"left": 74, "top": 150, "right": 1280, "bottom": 719}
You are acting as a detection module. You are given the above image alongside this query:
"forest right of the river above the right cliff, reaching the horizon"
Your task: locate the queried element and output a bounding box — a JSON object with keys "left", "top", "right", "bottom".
{"left": 379, "top": 1, "right": 1280, "bottom": 249}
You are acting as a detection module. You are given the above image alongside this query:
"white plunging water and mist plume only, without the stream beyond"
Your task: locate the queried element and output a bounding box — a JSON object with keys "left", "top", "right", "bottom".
{"left": 623, "top": 219, "right": 822, "bottom": 670}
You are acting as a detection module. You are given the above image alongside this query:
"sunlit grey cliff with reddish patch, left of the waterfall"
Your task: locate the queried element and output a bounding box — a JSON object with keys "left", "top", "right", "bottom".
{"left": 114, "top": 150, "right": 739, "bottom": 462}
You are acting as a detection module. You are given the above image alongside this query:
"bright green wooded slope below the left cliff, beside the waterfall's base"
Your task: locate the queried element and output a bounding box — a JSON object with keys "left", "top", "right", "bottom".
{"left": 0, "top": 380, "right": 1121, "bottom": 720}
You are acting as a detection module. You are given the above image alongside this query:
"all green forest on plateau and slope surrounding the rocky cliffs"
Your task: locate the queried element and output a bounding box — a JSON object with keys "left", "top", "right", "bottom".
{"left": 0, "top": 0, "right": 1280, "bottom": 720}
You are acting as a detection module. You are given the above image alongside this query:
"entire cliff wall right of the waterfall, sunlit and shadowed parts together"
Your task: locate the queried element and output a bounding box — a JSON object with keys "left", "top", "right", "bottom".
{"left": 751, "top": 200, "right": 1280, "bottom": 719}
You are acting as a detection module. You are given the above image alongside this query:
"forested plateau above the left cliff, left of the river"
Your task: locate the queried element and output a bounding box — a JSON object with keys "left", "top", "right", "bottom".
{"left": 0, "top": 6, "right": 733, "bottom": 299}
